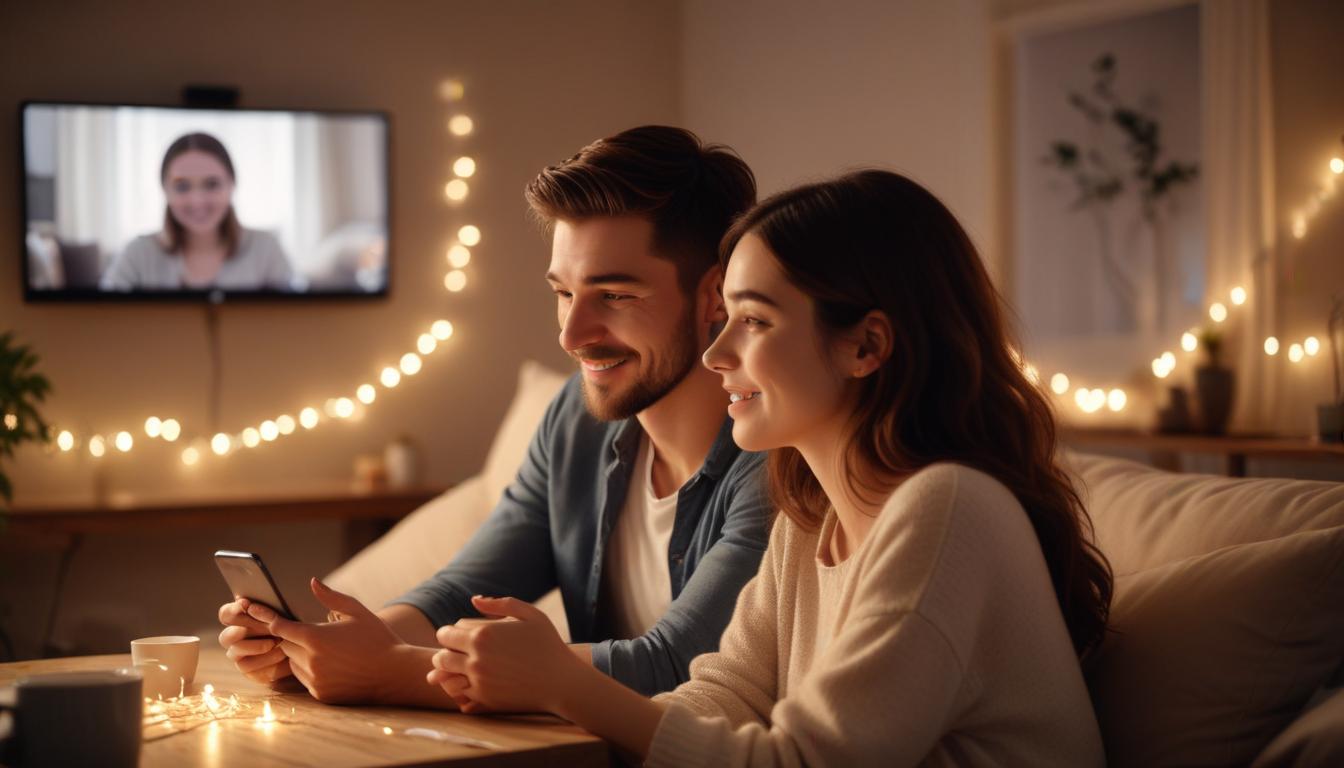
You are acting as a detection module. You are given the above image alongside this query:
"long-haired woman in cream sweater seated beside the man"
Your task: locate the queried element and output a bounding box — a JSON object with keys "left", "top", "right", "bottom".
{"left": 429, "top": 171, "right": 1111, "bottom": 765}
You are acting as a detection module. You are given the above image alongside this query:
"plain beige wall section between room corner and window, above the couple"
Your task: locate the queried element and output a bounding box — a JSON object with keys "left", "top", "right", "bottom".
{"left": 680, "top": 0, "right": 992, "bottom": 256}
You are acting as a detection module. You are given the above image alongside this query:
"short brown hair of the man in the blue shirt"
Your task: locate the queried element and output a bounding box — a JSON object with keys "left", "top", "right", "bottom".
{"left": 524, "top": 125, "right": 755, "bottom": 293}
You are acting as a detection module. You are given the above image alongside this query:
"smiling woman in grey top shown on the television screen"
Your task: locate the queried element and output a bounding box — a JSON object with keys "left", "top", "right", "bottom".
{"left": 99, "top": 133, "right": 293, "bottom": 291}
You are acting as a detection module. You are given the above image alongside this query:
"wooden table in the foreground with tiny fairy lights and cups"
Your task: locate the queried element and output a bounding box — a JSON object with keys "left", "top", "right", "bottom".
{"left": 0, "top": 647, "right": 609, "bottom": 768}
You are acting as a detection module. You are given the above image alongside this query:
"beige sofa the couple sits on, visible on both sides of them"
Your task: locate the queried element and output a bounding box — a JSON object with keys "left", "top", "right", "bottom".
{"left": 329, "top": 363, "right": 1344, "bottom": 767}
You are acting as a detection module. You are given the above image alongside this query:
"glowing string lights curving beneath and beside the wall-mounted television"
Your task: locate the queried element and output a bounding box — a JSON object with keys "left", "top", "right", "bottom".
{"left": 44, "top": 79, "right": 481, "bottom": 467}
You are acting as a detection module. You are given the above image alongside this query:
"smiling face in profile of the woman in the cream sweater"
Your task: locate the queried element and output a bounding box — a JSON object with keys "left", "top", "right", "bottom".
{"left": 704, "top": 233, "right": 852, "bottom": 451}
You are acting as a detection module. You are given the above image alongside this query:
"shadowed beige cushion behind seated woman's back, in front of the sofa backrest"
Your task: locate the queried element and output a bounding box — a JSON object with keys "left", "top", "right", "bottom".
{"left": 1089, "top": 527, "right": 1344, "bottom": 765}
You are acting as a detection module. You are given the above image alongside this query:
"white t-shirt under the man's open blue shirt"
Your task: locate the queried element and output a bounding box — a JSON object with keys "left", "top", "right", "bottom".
{"left": 603, "top": 436, "right": 677, "bottom": 640}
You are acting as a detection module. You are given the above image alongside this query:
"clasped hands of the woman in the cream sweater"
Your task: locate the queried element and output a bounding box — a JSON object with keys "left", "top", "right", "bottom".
{"left": 426, "top": 596, "right": 585, "bottom": 714}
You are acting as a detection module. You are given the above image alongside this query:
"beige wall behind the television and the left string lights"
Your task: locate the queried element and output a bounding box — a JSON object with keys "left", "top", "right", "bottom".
{"left": 0, "top": 0, "right": 679, "bottom": 655}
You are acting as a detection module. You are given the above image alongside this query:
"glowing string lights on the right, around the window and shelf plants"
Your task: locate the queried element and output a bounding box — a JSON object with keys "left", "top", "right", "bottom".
{"left": 1013, "top": 149, "right": 1344, "bottom": 413}
